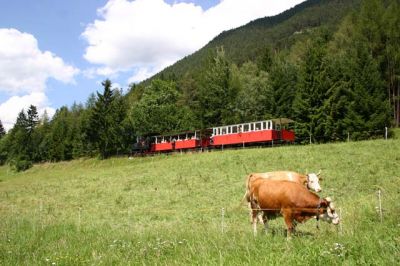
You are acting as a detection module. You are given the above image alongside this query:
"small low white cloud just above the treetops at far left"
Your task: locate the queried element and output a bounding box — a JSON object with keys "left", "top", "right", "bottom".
{"left": 0, "top": 92, "right": 55, "bottom": 130}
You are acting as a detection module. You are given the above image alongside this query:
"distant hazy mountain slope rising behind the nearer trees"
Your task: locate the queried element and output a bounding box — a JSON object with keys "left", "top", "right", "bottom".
{"left": 144, "top": 0, "right": 361, "bottom": 84}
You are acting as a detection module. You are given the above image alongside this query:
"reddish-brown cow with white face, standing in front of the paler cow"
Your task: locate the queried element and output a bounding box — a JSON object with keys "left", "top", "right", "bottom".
{"left": 250, "top": 178, "right": 339, "bottom": 237}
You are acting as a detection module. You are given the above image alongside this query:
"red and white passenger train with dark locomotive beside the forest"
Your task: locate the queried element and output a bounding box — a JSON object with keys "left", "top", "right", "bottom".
{"left": 132, "top": 118, "right": 295, "bottom": 155}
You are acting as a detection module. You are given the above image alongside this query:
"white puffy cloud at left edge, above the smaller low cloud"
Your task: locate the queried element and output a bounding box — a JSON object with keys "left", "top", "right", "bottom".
{"left": 0, "top": 29, "right": 79, "bottom": 95}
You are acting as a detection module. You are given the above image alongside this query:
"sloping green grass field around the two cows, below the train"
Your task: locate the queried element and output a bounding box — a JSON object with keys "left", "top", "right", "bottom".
{"left": 0, "top": 136, "right": 400, "bottom": 265}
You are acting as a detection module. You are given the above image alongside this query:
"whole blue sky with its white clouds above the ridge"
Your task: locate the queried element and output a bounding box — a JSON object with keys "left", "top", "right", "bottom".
{"left": 0, "top": 0, "right": 302, "bottom": 129}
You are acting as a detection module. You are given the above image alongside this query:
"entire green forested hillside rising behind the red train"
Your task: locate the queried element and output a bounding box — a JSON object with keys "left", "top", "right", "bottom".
{"left": 0, "top": 0, "right": 400, "bottom": 170}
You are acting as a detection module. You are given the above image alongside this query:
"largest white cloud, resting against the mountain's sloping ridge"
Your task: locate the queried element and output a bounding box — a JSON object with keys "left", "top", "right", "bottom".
{"left": 82, "top": 0, "right": 303, "bottom": 81}
